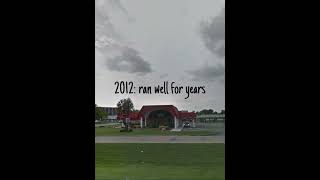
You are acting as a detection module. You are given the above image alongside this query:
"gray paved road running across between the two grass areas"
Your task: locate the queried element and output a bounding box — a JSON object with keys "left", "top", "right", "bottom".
{"left": 95, "top": 136, "right": 224, "bottom": 143}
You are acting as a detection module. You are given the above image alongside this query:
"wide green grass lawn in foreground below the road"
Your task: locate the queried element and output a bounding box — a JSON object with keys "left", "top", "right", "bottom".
{"left": 95, "top": 143, "right": 224, "bottom": 180}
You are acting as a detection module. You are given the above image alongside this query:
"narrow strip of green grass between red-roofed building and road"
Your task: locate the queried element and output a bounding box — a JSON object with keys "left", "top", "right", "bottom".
{"left": 95, "top": 127, "right": 217, "bottom": 136}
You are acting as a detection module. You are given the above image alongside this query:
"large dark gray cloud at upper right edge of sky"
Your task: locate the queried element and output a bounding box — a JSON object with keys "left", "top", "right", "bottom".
{"left": 200, "top": 8, "right": 225, "bottom": 57}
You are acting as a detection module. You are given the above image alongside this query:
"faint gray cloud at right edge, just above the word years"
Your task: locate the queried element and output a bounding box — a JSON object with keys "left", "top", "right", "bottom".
{"left": 186, "top": 65, "right": 225, "bottom": 80}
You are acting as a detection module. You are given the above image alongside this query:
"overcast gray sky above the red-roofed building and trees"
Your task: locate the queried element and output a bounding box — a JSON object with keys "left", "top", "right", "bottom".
{"left": 95, "top": 0, "right": 225, "bottom": 111}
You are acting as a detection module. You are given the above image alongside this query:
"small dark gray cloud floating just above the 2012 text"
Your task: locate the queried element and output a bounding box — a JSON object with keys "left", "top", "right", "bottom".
{"left": 107, "top": 47, "right": 152, "bottom": 75}
